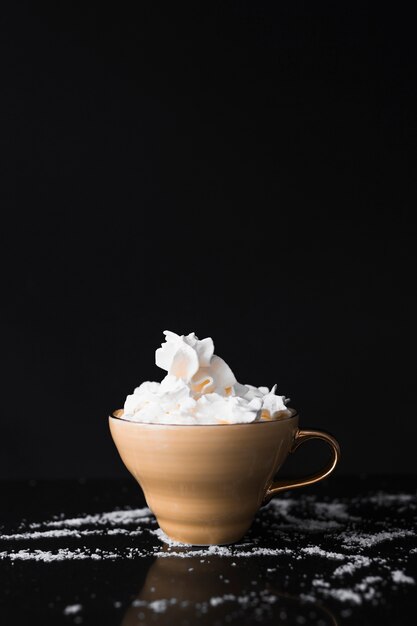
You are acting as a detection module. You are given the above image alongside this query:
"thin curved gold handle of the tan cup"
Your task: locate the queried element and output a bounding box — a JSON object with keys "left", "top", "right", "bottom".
{"left": 262, "top": 430, "right": 340, "bottom": 504}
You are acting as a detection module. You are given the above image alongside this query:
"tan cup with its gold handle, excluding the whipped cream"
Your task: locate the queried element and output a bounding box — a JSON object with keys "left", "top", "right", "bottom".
{"left": 109, "top": 410, "right": 340, "bottom": 545}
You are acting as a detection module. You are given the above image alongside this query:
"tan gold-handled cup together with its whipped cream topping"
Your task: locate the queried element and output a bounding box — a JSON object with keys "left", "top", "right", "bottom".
{"left": 109, "top": 331, "right": 340, "bottom": 545}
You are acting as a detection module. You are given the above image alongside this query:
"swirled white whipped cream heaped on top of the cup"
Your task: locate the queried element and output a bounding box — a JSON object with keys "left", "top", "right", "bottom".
{"left": 123, "top": 330, "right": 291, "bottom": 425}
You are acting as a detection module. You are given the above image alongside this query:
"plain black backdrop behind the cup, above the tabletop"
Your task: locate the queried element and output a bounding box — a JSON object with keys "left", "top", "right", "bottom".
{"left": 0, "top": 1, "right": 417, "bottom": 478}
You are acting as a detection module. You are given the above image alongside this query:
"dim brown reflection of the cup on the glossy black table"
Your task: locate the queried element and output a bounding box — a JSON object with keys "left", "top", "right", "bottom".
{"left": 121, "top": 548, "right": 337, "bottom": 626}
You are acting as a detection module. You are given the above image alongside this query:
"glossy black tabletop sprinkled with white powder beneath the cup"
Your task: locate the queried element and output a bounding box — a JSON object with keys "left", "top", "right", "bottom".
{"left": 0, "top": 477, "right": 417, "bottom": 626}
